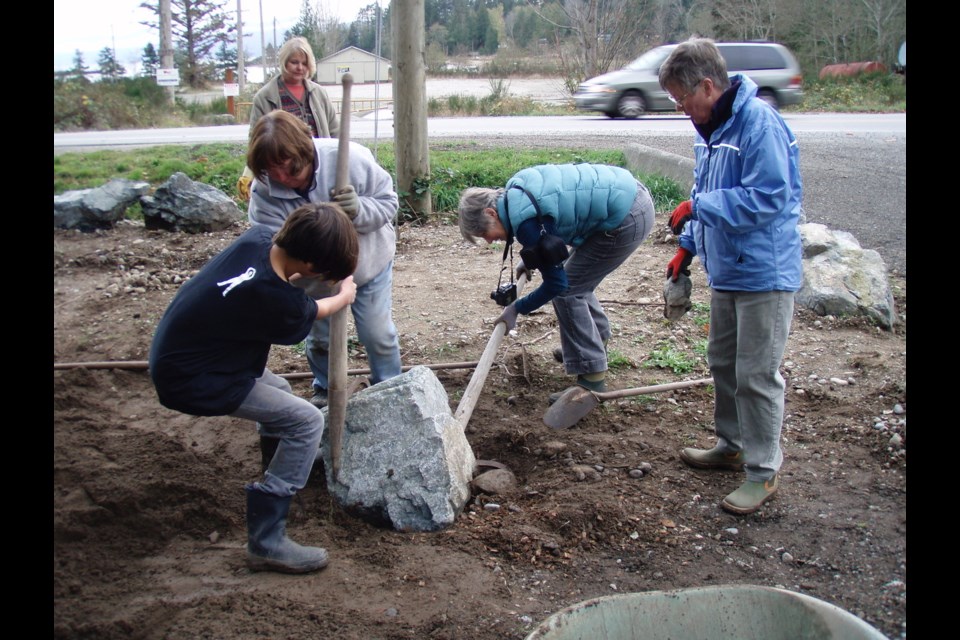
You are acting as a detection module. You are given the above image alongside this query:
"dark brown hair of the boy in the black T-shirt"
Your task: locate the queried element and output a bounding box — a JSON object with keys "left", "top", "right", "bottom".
{"left": 273, "top": 202, "right": 360, "bottom": 280}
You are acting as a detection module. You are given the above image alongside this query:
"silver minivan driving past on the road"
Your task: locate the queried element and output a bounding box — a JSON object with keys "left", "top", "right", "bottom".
{"left": 573, "top": 42, "right": 803, "bottom": 119}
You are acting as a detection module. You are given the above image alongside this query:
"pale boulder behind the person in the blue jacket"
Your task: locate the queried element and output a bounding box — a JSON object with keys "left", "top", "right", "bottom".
{"left": 796, "top": 223, "right": 897, "bottom": 330}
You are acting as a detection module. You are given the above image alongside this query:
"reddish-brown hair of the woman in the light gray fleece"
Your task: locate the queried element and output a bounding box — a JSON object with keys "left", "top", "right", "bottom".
{"left": 247, "top": 109, "right": 315, "bottom": 178}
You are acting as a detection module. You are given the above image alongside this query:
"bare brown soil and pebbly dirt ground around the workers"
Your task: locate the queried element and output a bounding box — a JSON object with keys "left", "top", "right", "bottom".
{"left": 53, "top": 213, "right": 907, "bottom": 640}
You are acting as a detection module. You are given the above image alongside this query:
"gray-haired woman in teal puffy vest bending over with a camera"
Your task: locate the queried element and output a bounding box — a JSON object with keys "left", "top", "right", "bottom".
{"left": 459, "top": 164, "right": 654, "bottom": 401}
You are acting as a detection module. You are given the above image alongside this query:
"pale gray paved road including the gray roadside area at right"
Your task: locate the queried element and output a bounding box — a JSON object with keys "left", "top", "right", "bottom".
{"left": 53, "top": 112, "right": 907, "bottom": 276}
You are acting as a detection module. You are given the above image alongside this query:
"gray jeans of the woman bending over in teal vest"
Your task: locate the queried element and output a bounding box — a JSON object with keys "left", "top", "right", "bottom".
{"left": 553, "top": 182, "right": 654, "bottom": 375}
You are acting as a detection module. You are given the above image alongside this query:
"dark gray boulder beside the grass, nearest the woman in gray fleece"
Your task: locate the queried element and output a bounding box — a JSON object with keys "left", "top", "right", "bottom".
{"left": 140, "top": 172, "right": 246, "bottom": 233}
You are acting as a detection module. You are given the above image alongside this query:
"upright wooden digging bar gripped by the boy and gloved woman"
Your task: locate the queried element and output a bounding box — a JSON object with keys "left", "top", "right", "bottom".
{"left": 327, "top": 73, "right": 353, "bottom": 479}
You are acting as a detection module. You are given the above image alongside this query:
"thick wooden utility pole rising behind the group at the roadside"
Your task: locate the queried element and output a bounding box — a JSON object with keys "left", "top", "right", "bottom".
{"left": 391, "top": 0, "right": 431, "bottom": 224}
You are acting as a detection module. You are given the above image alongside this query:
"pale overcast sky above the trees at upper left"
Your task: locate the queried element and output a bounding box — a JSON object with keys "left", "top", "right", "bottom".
{"left": 53, "top": 0, "right": 376, "bottom": 70}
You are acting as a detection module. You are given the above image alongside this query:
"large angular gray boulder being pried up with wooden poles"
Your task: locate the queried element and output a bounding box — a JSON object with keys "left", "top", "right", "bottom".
{"left": 321, "top": 367, "right": 476, "bottom": 531}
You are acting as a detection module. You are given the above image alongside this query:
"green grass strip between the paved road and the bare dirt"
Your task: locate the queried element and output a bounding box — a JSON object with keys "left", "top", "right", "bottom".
{"left": 53, "top": 142, "right": 684, "bottom": 222}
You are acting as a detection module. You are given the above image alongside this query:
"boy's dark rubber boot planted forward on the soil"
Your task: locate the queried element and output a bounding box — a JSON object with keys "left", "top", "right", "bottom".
{"left": 246, "top": 485, "right": 328, "bottom": 573}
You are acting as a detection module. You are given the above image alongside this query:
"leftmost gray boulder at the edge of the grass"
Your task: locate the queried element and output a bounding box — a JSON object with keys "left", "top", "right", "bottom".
{"left": 53, "top": 178, "right": 150, "bottom": 231}
